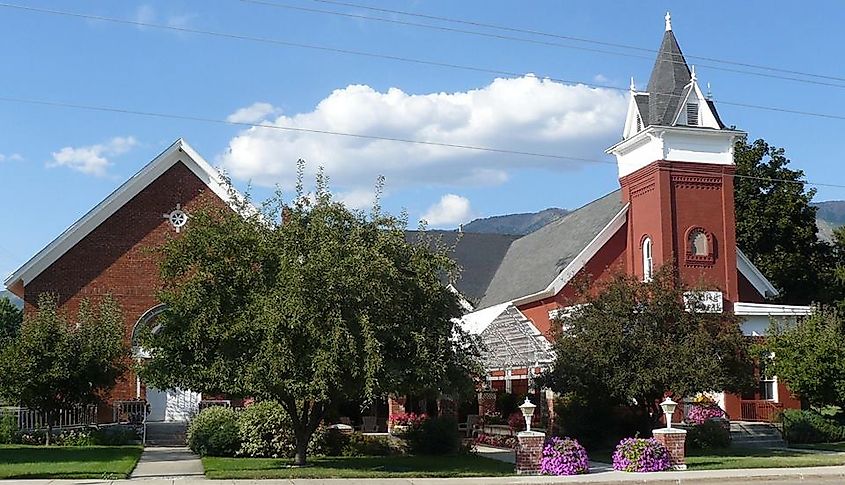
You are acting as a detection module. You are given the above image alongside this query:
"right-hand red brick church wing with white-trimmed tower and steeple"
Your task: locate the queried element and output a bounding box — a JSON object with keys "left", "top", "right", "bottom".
{"left": 463, "top": 14, "right": 810, "bottom": 420}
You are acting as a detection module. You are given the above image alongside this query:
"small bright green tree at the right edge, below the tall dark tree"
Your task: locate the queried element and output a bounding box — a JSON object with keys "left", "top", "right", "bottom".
{"left": 762, "top": 309, "right": 845, "bottom": 406}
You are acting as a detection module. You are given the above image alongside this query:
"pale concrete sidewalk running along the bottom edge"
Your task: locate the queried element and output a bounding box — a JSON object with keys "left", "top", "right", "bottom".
{"left": 0, "top": 466, "right": 845, "bottom": 485}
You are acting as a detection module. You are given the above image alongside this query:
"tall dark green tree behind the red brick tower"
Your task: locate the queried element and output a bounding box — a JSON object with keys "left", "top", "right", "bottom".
{"left": 734, "top": 140, "right": 842, "bottom": 304}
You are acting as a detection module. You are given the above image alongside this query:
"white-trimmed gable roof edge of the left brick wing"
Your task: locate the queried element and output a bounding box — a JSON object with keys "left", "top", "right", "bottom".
{"left": 4, "top": 138, "right": 239, "bottom": 296}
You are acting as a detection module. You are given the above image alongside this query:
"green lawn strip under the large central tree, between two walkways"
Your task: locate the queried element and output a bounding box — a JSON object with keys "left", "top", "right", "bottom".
{"left": 202, "top": 455, "right": 514, "bottom": 479}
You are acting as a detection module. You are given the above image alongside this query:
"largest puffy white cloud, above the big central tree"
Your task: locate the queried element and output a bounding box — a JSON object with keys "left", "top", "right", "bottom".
{"left": 219, "top": 75, "right": 627, "bottom": 190}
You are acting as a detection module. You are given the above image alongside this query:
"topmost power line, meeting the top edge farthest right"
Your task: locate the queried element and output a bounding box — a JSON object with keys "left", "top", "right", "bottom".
{"left": 304, "top": 0, "right": 845, "bottom": 81}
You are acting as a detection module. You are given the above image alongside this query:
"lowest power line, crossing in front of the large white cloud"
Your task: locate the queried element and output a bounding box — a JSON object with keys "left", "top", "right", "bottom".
{"left": 0, "top": 91, "right": 845, "bottom": 189}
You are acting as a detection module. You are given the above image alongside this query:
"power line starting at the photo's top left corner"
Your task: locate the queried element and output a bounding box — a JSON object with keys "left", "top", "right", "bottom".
{"left": 0, "top": 2, "right": 845, "bottom": 120}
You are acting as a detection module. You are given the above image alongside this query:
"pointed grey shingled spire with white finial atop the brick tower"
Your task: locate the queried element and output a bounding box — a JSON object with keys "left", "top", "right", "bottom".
{"left": 647, "top": 13, "right": 690, "bottom": 125}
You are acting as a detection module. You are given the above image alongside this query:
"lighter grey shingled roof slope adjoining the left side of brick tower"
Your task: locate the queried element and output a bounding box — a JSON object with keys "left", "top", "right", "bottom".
{"left": 478, "top": 190, "right": 624, "bottom": 309}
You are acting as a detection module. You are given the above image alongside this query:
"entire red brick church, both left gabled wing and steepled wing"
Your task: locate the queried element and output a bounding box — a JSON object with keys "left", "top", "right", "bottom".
{"left": 5, "top": 16, "right": 810, "bottom": 422}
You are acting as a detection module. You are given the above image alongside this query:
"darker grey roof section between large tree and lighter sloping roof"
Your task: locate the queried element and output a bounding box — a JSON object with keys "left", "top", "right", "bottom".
{"left": 405, "top": 231, "right": 519, "bottom": 306}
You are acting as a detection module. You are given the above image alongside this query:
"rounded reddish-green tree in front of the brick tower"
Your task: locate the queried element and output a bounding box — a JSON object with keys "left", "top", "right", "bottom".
{"left": 544, "top": 267, "right": 753, "bottom": 431}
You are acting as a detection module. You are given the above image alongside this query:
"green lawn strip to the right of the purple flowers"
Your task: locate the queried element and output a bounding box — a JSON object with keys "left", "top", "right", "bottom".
{"left": 589, "top": 448, "right": 845, "bottom": 470}
